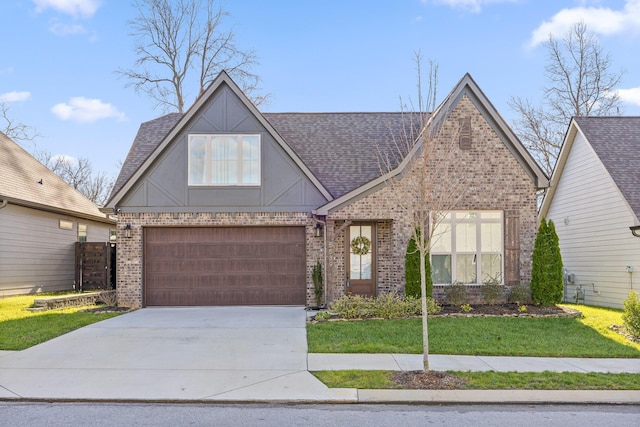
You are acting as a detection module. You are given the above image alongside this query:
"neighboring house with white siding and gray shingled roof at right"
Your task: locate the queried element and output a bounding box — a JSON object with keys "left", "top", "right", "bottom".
{"left": 540, "top": 117, "right": 640, "bottom": 308}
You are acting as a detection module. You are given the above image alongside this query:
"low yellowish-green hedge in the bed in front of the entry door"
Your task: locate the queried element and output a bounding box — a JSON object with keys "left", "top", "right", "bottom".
{"left": 330, "top": 293, "right": 441, "bottom": 319}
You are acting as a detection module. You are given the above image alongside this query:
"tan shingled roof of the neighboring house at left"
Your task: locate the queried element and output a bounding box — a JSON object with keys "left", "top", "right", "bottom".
{"left": 0, "top": 132, "right": 113, "bottom": 222}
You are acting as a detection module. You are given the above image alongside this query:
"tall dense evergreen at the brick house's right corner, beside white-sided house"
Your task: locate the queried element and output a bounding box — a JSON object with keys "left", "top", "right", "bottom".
{"left": 531, "top": 218, "right": 563, "bottom": 305}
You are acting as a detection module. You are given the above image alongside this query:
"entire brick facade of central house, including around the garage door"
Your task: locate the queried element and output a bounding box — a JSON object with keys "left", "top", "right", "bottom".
{"left": 117, "top": 95, "right": 537, "bottom": 308}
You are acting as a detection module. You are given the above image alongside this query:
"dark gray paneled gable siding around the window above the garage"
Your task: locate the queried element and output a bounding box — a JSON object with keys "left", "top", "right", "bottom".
{"left": 119, "top": 85, "right": 327, "bottom": 212}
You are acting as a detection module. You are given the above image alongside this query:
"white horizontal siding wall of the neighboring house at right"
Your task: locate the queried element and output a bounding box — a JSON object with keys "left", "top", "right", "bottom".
{"left": 547, "top": 132, "right": 640, "bottom": 308}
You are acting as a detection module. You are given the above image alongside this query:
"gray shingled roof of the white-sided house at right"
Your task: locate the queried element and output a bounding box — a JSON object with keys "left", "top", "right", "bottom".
{"left": 573, "top": 117, "right": 640, "bottom": 218}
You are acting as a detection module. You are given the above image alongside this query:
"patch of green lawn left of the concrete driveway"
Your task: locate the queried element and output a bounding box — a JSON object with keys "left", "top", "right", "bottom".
{"left": 0, "top": 294, "right": 118, "bottom": 350}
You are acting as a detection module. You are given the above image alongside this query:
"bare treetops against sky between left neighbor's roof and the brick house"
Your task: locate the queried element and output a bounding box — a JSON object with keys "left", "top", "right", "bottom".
{"left": 35, "top": 150, "right": 114, "bottom": 206}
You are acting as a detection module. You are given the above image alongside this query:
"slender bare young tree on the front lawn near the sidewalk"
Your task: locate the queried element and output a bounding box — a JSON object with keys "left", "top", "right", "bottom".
{"left": 378, "top": 52, "right": 469, "bottom": 371}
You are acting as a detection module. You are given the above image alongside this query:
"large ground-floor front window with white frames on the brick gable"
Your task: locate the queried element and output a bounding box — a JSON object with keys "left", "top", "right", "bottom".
{"left": 431, "top": 211, "right": 503, "bottom": 284}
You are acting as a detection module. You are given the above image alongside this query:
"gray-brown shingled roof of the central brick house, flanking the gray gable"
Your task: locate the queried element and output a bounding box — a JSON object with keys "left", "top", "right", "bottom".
{"left": 112, "top": 113, "right": 415, "bottom": 197}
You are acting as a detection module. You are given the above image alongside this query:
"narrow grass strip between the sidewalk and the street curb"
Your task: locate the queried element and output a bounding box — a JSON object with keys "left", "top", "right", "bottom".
{"left": 312, "top": 370, "right": 640, "bottom": 390}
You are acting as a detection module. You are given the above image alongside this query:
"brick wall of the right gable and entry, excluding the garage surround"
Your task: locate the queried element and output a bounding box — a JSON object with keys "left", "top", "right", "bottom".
{"left": 327, "top": 95, "right": 537, "bottom": 302}
